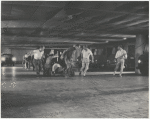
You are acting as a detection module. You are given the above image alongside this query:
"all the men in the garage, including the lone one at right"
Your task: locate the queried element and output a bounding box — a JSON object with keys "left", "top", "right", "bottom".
{"left": 23, "top": 44, "right": 127, "bottom": 77}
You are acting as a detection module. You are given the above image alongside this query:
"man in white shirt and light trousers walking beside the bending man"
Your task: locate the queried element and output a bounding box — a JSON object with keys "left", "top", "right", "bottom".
{"left": 79, "top": 45, "right": 94, "bottom": 76}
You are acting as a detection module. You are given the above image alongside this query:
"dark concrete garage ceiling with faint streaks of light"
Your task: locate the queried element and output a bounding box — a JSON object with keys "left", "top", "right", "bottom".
{"left": 1, "top": 1, "right": 149, "bottom": 48}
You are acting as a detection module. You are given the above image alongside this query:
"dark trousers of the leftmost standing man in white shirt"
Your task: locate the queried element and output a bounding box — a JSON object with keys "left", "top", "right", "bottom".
{"left": 33, "top": 59, "right": 42, "bottom": 74}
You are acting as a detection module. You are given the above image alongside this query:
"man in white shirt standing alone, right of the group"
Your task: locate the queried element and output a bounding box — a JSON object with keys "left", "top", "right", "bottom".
{"left": 113, "top": 45, "right": 127, "bottom": 77}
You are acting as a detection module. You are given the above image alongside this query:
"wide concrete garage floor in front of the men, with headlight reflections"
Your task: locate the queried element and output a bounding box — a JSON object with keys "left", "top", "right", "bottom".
{"left": 1, "top": 67, "right": 149, "bottom": 118}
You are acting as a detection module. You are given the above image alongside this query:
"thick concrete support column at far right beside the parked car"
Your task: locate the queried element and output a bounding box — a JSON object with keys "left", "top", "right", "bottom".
{"left": 135, "top": 34, "right": 148, "bottom": 74}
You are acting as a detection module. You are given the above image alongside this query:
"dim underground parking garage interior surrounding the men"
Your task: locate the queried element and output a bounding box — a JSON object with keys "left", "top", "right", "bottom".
{"left": 1, "top": 1, "right": 149, "bottom": 118}
